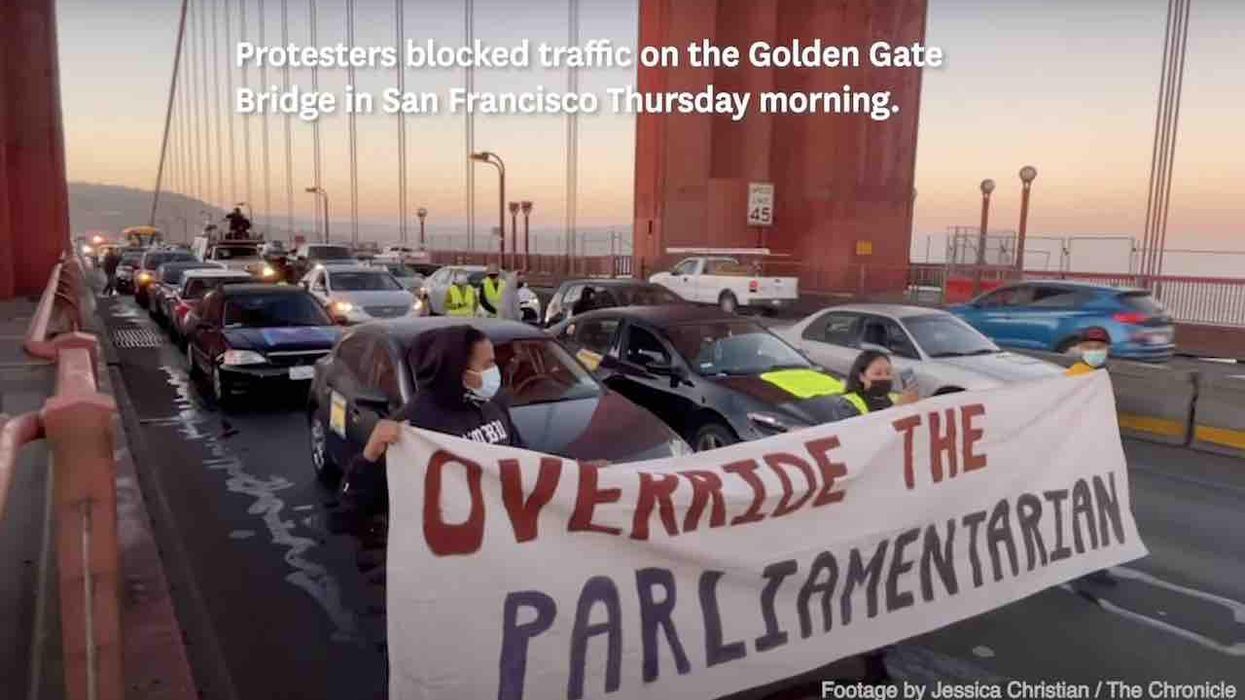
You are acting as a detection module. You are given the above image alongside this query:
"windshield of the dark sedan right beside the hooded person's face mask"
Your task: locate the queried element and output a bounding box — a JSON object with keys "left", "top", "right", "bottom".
{"left": 494, "top": 339, "right": 601, "bottom": 406}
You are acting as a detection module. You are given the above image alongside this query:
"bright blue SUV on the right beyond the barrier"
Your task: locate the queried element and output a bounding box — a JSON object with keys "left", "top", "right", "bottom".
{"left": 950, "top": 281, "right": 1175, "bottom": 362}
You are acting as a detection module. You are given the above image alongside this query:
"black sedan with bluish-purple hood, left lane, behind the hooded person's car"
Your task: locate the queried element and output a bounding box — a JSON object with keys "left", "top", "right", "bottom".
{"left": 186, "top": 284, "right": 340, "bottom": 407}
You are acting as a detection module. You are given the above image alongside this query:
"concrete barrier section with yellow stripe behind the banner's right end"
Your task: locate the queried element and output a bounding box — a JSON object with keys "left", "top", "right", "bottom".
{"left": 1021, "top": 350, "right": 1198, "bottom": 445}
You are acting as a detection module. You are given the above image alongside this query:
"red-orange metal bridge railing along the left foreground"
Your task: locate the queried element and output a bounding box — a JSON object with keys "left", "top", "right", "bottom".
{"left": 0, "top": 257, "right": 125, "bottom": 700}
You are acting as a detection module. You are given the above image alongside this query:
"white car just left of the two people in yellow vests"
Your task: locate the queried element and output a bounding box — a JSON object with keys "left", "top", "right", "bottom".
{"left": 299, "top": 265, "right": 422, "bottom": 324}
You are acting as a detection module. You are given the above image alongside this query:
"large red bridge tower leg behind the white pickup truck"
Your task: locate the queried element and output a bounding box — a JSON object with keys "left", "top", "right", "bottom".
{"left": 635, "top": 0, "right": 926, "bottom": 291}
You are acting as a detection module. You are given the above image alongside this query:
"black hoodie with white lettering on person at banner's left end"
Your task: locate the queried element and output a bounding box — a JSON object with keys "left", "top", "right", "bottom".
{"left": 402, "top": 325, "right": 523, "bottom": 447}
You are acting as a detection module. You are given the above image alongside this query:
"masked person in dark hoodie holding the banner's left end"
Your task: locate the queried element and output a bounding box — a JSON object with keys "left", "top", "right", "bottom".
{"left": 337, "top": 325, "right": 523, "bottom": 529}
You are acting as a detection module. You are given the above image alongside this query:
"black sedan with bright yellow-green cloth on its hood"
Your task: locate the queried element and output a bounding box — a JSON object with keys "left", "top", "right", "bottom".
{"left": 553, "top": 305, "right": 844, "bottom": 451}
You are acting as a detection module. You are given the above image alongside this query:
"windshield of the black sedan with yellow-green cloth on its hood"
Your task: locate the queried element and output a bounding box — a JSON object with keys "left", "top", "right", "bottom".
{"left": 666, "top": 321, "right": 812, "bottom": 376}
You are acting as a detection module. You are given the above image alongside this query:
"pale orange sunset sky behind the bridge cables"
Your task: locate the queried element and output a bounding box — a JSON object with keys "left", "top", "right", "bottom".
{"left": 57, "top": 0, "right": 1245, "bottom": 256}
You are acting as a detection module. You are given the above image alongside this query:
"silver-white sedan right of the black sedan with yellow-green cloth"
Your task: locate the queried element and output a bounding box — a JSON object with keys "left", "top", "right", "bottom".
{"left": 774, "top": 304, "right": 1063, "bottom": 396}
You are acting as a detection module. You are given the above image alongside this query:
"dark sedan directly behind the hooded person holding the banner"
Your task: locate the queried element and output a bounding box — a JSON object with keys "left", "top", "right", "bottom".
{"left": 308, "top": 318, "right": 690, "bottom": 483}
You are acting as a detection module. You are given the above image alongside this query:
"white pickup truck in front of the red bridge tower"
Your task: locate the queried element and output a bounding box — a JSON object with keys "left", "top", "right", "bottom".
{"left": 649, "top": 255, "right": 799, "bottom": 314}
